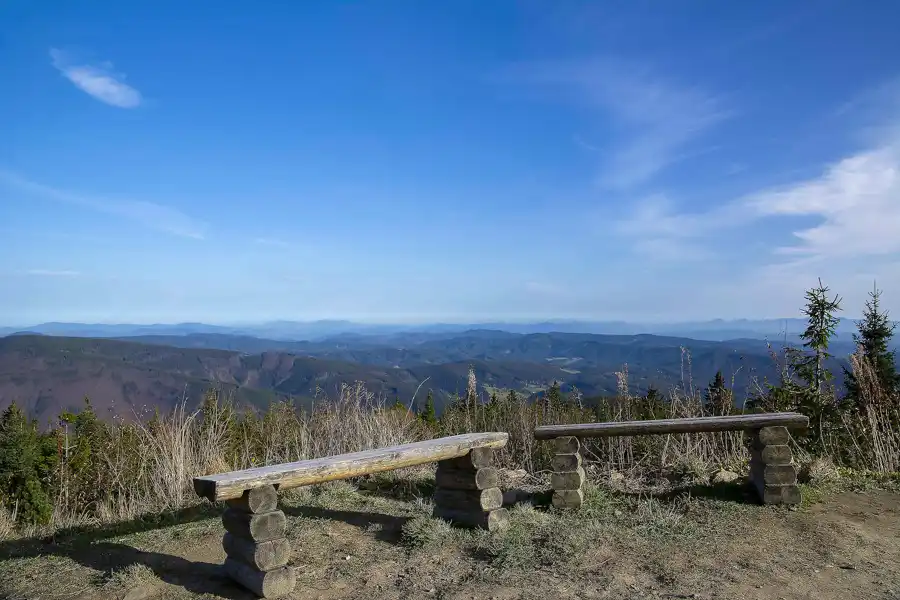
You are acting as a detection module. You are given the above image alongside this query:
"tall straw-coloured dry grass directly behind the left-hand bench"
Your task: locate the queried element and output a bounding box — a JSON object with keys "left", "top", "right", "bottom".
{"left": 46, "top": 384, "right": 427, "bottom": 533}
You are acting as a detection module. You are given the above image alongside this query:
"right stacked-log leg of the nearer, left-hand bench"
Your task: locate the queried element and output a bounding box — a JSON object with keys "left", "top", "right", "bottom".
{"left": 434, "top": 448, "right": 509, "bottom": 531}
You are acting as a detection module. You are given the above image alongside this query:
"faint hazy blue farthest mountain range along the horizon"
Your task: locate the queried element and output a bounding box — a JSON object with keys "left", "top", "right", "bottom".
{"left": 0, "top": 318, "right": 856, "bottom": 342}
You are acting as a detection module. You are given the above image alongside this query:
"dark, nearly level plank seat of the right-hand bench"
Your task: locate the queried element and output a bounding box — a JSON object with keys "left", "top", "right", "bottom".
{"left": 534, "top": 413, "right": 809, "bottom": 440}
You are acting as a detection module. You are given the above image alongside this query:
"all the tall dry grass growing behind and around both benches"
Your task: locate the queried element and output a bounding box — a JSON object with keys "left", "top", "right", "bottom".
{"left": 0, "top": 357, "right": 900, "bottom": 539}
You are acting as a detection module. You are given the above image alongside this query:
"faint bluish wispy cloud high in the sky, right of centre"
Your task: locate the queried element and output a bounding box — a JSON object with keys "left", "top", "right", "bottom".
{"left": 503, "top": 60, "right": 732, "bottom": 189}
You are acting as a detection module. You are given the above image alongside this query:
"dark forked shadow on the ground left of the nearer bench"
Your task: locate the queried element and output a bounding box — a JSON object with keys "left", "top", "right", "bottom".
{"left": 0, "top": 504, "right": 256, "bottom": 600}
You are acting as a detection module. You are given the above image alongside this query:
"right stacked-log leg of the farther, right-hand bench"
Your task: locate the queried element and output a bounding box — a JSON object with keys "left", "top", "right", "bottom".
{"left": 749, "top": 427, "right": 800, "bottom": 505}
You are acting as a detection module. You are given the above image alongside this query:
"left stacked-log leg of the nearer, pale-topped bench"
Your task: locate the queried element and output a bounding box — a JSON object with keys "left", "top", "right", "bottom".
{"left": 222, "top": 485, "right": 296, "bottom": 598}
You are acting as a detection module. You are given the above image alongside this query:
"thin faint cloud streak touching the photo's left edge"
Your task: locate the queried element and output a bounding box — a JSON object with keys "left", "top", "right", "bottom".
{"left": 0, "top": 170, "right": 206, "bottom": 240}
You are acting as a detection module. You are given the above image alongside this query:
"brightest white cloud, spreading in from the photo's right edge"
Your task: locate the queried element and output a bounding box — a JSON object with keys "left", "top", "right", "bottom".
{"left": 616, "top": 116, "right": 900, "bottom": 266}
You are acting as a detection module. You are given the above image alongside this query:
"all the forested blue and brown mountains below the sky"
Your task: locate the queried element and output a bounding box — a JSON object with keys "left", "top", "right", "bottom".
{"left": 0, "top": 324, "right": 852, "bottom": 422}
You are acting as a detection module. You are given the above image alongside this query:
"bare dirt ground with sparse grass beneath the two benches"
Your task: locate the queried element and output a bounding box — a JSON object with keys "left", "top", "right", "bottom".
{"left": 0, "top": 476, "right": 900, "bottom": 600}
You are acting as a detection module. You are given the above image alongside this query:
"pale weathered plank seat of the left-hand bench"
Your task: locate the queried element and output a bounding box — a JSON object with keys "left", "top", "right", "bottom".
{"left": 194, "top": 432, "right": 509, "bottom": 502}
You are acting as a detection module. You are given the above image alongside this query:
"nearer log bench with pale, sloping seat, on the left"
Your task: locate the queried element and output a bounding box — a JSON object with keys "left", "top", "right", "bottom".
{"left": 194, "top": 433, "right": 509, "bottom": 598}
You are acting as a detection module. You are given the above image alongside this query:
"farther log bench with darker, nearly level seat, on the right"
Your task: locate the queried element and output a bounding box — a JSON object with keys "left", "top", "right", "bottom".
{"left": 534, "top": 413, "right": 809, "bottom": 508}
